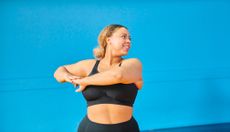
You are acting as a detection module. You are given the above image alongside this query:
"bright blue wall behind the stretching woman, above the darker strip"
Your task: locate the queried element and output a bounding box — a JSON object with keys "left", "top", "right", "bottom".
{"left": 0, "top": 0, "right": 230, "bottom": 132}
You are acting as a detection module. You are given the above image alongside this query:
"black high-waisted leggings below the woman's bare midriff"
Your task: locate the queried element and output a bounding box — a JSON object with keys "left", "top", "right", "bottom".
{"left": 78, "top": 115, "right": 140, "bottom": 132}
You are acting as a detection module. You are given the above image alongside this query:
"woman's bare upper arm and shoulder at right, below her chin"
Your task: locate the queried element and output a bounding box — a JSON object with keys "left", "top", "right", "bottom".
{"left": 120, "top": 58, "right": 142, "bottom": 84}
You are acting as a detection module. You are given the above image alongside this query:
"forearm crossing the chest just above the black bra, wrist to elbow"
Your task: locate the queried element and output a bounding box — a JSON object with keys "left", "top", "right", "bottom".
{"left": 82, "top": 70, "right": 122, "bottom": 85}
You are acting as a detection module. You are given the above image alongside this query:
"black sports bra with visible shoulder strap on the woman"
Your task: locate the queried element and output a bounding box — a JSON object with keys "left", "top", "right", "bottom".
{"left": 82, "top": 60, "right": 138, "bottom": 106}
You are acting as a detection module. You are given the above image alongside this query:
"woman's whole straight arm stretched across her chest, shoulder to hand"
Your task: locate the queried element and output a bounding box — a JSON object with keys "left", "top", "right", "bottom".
{"left": 76, "top": 59, "right": 142, "bottom": 86}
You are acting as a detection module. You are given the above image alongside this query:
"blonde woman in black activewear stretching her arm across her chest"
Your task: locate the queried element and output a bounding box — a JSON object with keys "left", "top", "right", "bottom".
{"left": 54, "top": 24, "right": 143, "bottom": 132}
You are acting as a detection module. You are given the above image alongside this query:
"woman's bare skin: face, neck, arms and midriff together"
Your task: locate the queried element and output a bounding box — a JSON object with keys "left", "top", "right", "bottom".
{"left": 54, "top": 28, "right": 143, "bottom": 124}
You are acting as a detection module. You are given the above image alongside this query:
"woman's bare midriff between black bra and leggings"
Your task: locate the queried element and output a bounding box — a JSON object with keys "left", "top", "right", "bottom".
{"left": 87, "top": 104, "right": 133, "bottom": 124}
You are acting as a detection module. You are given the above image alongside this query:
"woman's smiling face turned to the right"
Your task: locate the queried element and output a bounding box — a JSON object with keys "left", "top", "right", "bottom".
{"left": 107, "top": 27, "right": 131, "bottom": 56}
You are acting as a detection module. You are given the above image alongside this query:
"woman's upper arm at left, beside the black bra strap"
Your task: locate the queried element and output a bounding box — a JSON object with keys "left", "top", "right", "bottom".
{"left": 64, "top": 59, "right": 95, "bottom": 77}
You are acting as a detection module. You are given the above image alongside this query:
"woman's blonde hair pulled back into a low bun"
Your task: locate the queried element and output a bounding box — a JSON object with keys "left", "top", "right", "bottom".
{"left": 93, "top": 24, "right": 127, "bottom": 59}
